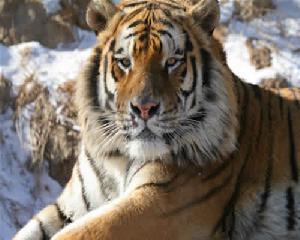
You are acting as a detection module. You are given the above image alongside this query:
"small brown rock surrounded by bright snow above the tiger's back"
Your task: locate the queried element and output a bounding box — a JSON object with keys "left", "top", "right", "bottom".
{"left": 246, "top": 39, "right": 272, "bottom": 69}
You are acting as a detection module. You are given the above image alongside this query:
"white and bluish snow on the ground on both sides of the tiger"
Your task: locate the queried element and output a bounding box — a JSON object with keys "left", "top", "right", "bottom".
{"left": 0, "top": 0, "right": 300, "bottom": 240}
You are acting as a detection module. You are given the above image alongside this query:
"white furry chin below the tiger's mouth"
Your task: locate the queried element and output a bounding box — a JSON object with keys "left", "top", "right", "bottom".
{"left": 126, "top": 138, "right": 171, "bottom": 162}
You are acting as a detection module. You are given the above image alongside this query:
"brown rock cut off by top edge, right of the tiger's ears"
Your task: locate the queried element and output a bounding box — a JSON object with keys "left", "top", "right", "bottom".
{"left": 235, "top": 0, "right": 275, "bottom": 21}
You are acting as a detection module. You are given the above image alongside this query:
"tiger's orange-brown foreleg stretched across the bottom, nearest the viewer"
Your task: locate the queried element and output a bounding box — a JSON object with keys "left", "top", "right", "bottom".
{"left": 53, "top": 163, "right": 235, "bottom": 240}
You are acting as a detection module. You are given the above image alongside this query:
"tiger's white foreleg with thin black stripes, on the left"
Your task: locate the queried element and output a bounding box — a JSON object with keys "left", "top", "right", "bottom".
{"left": 13, "top": 151, "right": 113, "bottom": 240}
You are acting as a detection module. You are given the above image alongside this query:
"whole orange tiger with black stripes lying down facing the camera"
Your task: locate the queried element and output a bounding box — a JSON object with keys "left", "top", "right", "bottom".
{"left": 14, "top": 0, "right": 300, "bottom": 240}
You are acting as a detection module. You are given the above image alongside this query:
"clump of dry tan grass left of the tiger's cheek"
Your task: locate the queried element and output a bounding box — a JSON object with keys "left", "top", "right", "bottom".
{"left": 15, "top": 74, "right": 80, "bottom": 185}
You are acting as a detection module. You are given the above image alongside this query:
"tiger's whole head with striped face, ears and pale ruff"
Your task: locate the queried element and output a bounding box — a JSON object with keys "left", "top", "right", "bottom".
{"left": 77, "top": 0, "right": 236, "bottom": 164}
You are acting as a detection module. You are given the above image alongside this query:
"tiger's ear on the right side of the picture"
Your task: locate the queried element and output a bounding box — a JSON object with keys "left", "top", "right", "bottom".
{"left": 190, "top": 0, "right": 220, "bottom": 35}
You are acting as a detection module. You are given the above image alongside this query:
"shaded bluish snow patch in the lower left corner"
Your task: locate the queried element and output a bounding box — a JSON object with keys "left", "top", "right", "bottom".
{"left": 0, "top": 110, "right": 61, "bottom": 239}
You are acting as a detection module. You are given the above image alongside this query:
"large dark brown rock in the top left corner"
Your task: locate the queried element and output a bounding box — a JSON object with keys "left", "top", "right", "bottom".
{"left": 0, "top": 0, "right": 80, "bottom": 48}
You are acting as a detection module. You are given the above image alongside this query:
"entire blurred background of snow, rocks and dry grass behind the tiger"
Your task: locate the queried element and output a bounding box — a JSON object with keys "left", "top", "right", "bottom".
{"left": 0, "top": 0, "right": 300, "bottom": 240}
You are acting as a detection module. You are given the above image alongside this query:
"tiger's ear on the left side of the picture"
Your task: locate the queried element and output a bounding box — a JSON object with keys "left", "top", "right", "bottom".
{"left": 86, "top": 0, "right": 118, "bottom": 32}
